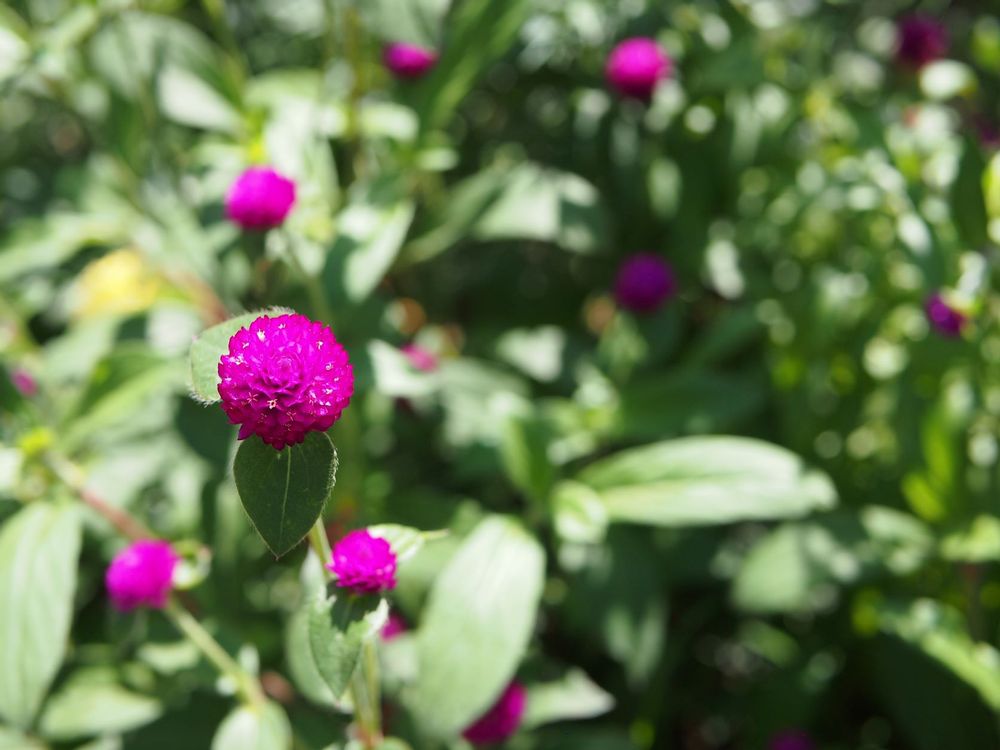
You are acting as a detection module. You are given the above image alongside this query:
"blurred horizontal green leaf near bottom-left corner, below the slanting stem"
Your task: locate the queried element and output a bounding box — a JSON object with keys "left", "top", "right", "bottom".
{"left": 39, "top": 670, "right": 163, "bottom": 741}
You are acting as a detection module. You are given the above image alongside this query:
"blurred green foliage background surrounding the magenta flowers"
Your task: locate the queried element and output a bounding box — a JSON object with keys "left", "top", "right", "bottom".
{"left": 0, "top": 0, "right": 1000, "bottom": 750}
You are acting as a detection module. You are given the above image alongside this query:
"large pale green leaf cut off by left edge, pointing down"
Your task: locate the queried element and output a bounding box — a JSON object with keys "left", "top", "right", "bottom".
{"left": 0, "top": 502, "right": 80, "bottom": 728}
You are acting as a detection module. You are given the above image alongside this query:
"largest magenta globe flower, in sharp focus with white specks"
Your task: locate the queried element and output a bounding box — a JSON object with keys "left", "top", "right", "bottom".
{"left": 219, "top": 314, "right": 354, "bottom": 450}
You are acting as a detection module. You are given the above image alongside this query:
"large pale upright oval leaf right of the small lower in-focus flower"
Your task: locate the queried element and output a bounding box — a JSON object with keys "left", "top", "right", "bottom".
{"left": 408, "top": 516, "right": 545, "bottom": 737}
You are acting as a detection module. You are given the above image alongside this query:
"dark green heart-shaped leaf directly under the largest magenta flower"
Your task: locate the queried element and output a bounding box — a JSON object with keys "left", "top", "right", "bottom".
{"left": 233, "top": 432, "right": 337, "bottom": 557}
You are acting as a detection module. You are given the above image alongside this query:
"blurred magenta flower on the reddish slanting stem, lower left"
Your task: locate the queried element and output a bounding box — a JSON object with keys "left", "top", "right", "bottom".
{"left": 104, "top": 539, "right": 180, "bottom": 612}
